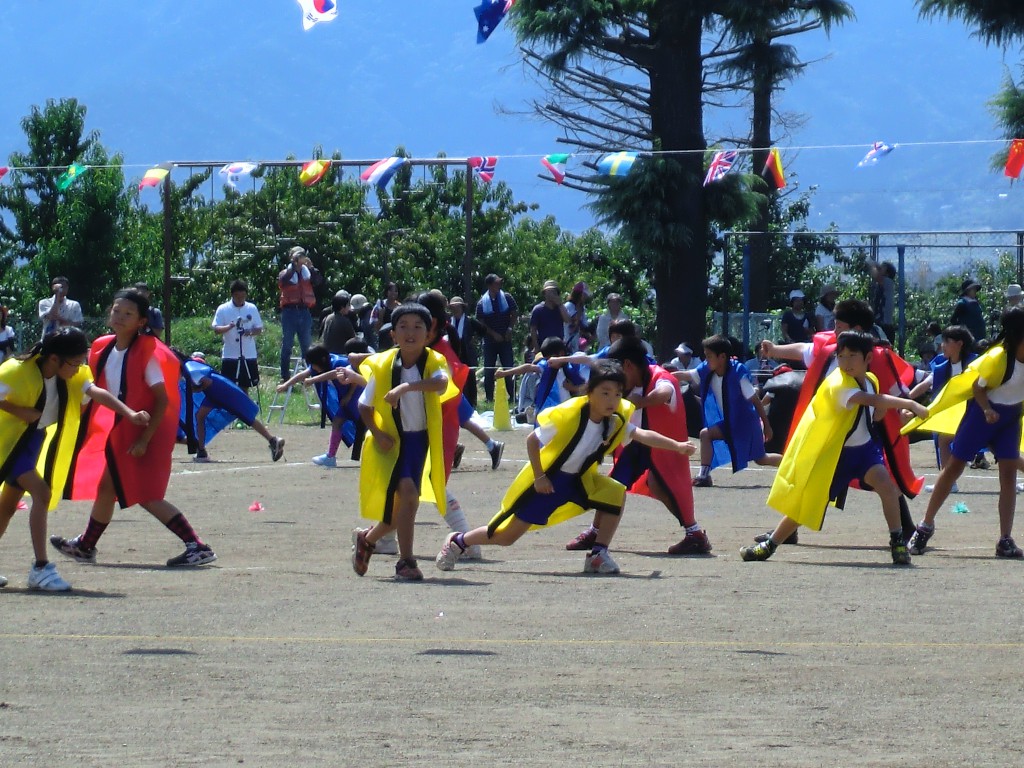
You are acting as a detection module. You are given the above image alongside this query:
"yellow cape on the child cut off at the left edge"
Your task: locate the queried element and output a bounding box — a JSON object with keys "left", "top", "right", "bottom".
{"left": 0, "top": 355, "right": 92, "bottom": 511}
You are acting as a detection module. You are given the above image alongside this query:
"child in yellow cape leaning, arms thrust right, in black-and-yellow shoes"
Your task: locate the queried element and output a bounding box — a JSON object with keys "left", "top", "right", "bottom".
{"left": 739, "top": 331, "right": 928, "bottom": 565}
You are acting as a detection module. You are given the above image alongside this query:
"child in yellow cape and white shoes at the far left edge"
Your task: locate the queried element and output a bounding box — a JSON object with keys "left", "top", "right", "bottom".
{"left": 0, "top": 328, "right": 150, "bottom": 592}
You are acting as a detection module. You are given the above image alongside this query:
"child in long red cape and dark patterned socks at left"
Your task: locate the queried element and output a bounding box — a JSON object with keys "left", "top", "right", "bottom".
{"left": 50, "top": 291, "right": 217, "bottom": 567}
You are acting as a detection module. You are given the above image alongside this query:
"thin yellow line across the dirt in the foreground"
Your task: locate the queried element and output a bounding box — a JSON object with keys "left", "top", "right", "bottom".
{"left": 0, "top": 632, "right": 1024, "bottom": 650}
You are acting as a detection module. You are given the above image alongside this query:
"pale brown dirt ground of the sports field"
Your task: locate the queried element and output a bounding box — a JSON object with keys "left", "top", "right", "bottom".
{"left": 0, "top": 427, "right": 1024, "bottom": 767}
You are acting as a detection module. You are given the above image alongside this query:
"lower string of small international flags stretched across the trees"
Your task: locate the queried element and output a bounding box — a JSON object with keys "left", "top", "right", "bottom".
{"left": 8, "top": 138, "right": 1024, "bottom": 191}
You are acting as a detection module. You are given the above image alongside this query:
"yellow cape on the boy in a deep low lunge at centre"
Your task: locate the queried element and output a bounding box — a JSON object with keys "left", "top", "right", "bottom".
{"left": 487, "top": 397, "right": 634, "bottom": 536}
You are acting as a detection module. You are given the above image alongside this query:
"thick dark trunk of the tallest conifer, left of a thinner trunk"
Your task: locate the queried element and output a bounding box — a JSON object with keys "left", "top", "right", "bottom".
{"left": 650, "top": 2, "right": 709, "bottom": 359}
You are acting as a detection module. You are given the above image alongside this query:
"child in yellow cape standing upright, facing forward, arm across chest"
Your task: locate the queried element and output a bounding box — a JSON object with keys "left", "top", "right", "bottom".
{"left": 352, "top": 303, "right": 459, "bottom": 582}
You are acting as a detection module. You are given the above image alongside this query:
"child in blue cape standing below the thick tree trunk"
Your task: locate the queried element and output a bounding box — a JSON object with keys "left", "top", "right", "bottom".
{"left": 674, "top": 335, "right": 782, "bottom": 487}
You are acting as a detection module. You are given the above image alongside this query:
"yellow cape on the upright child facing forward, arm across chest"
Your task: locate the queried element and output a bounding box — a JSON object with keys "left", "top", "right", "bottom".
{"left": 359, "top": 347, "right": 459, "bottom": 523}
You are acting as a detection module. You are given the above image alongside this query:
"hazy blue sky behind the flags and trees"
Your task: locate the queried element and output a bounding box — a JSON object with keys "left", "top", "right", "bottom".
{"left": 0, "top": 0, "right": 1019, "bottom": 230}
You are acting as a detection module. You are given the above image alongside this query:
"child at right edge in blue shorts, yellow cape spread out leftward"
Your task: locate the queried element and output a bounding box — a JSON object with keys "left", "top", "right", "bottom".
{"left": 903, "top": 307, "right": 1024, "bottom": 559}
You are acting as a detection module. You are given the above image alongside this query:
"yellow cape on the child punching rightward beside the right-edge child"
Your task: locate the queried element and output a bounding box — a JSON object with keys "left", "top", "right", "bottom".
{"left": 768, "top": 369, "right": 879, "bottom": 530}
